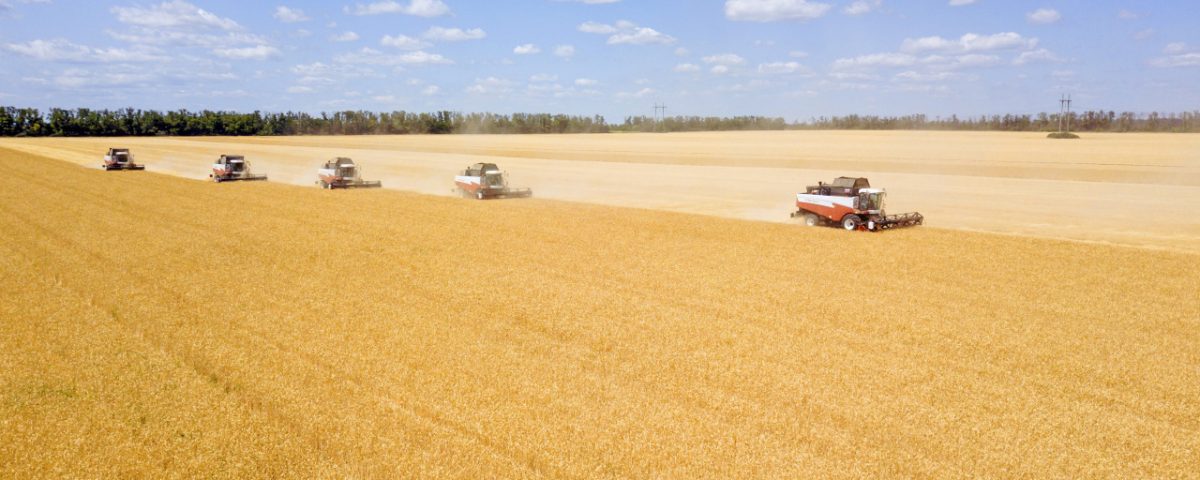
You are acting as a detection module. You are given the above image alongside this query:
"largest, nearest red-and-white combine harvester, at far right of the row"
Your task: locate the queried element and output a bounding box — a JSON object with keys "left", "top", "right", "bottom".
{"left": 792, "top": 176, "right": 925, "bottom": 232}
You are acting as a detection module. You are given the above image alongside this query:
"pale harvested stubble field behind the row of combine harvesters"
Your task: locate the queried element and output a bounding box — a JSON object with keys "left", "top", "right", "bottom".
{"left": 0, "top": 132, "right": 1200, "bottom": 253}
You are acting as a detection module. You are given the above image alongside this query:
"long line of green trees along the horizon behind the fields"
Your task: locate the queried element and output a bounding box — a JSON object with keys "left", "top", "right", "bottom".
{"left": 0, "top": 107, "right": 1200, "bottom": 137}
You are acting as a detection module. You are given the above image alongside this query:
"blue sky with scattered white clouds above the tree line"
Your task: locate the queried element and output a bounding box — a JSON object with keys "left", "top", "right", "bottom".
{"left": 0, "top": 0, "right": 1200, "bottom": 121}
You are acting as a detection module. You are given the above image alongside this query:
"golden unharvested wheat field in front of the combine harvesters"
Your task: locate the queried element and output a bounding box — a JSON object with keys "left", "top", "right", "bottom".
{"left": 0, "top": 150, "right": 1200, "bottom": 478}
